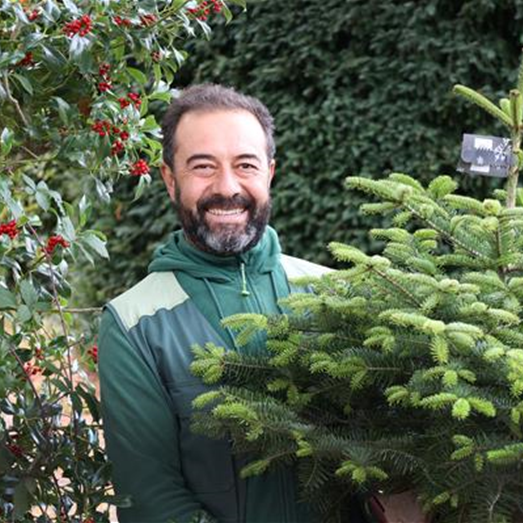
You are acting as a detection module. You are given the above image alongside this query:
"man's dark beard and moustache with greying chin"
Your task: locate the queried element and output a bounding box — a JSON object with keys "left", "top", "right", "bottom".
{"left": 175, "top": 192, "right": 271, "bottom": 256}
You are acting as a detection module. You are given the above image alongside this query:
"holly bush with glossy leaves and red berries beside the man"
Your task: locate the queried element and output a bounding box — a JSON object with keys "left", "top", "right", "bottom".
{"left": 0, "top": 0, "right": 244, "bottom": 523}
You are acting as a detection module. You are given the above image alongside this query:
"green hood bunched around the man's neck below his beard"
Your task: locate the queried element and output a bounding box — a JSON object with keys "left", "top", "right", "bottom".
{"left": 149, "top": 227, "right": 281, "bottom": 282}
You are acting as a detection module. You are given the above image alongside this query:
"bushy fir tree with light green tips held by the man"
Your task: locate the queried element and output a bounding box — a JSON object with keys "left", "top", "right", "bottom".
{"left": 193, "top": 55, "right": 523, "bottom": 523}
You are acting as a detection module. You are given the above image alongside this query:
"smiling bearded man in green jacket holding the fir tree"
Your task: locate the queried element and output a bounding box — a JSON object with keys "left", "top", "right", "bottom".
{"left": 99, "top": 85, "right": 360, "bottom": 523}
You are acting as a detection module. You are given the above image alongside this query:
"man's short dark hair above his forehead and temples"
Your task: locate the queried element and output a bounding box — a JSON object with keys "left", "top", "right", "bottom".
{"left": 162, "top": 84, "right": 276, "bottom": 169}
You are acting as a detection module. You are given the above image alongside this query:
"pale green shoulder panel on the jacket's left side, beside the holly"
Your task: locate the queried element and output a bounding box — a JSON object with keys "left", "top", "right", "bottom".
{"left": 109, "top": 272, "right": 189, "bottom": 330}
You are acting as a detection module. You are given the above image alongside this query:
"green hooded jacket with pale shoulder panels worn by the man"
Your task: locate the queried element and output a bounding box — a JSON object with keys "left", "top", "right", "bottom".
{"left": 98, "top": 228, "right": 350, "bottom": 523}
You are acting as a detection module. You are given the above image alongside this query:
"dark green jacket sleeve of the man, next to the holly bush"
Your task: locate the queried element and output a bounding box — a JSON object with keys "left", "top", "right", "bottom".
{"left": 98, "top": 310, "right": 212, "bottom": 523}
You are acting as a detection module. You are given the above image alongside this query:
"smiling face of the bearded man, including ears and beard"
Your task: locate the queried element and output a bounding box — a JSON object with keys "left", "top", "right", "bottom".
{"left": 162, "top": 110, "right": 274, "bottom": 255}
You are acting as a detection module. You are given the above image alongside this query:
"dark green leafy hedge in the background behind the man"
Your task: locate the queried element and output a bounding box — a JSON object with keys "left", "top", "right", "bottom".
{"left": 83, "top": 0, "right": 523, "bottom": 303}
